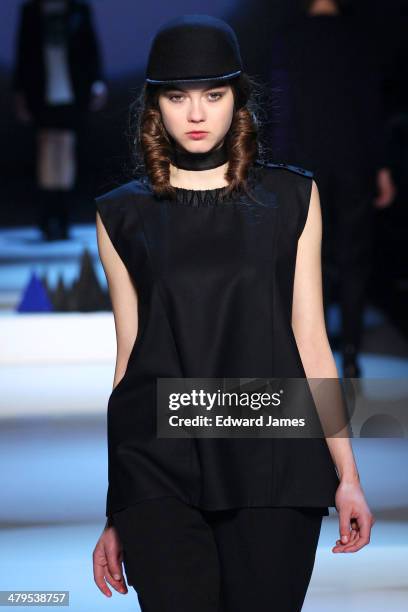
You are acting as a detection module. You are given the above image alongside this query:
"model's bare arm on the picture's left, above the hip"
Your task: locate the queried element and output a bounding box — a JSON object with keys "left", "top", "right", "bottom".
{"left": 96, "top": 212, "right": 138, "bottom": 388}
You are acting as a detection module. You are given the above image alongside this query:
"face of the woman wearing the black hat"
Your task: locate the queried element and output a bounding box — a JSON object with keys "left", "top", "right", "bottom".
{"left": 158, "top": 81, "right": 234, "bottom": 153}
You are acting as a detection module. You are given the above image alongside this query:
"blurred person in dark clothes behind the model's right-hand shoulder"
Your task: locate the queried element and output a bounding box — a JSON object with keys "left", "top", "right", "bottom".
{"left": 270, "top": 0, "right": 395, "bottom": 377}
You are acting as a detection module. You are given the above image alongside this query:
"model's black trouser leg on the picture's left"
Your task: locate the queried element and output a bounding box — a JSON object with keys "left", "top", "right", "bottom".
{"left": 113, "top": 497, "right": 220, "bottom": 612}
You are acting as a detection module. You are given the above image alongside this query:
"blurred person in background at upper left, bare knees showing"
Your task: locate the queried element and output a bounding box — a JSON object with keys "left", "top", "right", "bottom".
{"left": 12, "top": 0, "right": 107, "bottom": 240}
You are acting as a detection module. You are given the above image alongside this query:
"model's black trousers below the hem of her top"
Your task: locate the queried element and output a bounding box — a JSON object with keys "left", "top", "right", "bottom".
{"left": 113, "top": 497, "right": 323, "bottom": 612}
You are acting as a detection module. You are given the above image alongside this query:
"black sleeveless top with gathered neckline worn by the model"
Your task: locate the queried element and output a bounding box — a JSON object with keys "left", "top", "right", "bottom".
{"left": 95, "top": 161, "right": 339, "bottom": 520}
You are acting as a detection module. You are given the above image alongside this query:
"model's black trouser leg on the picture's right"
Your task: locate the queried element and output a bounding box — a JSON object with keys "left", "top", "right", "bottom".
{"left": 207, "top": 507, "right": 323, "bottom": 612}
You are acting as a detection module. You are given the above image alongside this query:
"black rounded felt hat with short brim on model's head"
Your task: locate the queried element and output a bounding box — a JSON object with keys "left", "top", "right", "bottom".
{"left": 146, "top": 15, "right": 243, "bottom": 84}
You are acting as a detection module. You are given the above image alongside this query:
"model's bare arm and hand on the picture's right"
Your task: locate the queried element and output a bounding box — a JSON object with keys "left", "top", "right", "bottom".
{"left": 292, "top": 181, "right": 374, "bottom": 552}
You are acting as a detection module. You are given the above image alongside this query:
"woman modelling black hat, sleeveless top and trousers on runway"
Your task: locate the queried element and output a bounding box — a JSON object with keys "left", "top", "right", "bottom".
{"left": 93, "top": 15, "right": 374, "bottom": 612}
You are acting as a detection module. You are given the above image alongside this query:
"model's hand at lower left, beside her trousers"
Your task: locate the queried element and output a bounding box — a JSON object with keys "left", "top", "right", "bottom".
{"left": 92, "top": 527, "right": 128, "bottom": 597}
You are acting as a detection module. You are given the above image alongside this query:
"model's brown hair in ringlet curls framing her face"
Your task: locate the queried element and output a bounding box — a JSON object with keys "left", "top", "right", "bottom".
{"left": 129, "top": 73, "right": 274, "bottom": 199}
